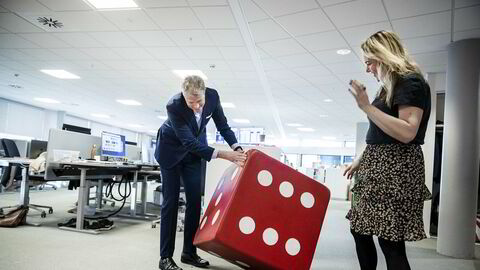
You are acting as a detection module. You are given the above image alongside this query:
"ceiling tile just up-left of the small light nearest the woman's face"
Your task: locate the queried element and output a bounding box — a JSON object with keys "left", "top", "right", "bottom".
{"left": 297, "top": 31, "right": 348, "bottom": 51}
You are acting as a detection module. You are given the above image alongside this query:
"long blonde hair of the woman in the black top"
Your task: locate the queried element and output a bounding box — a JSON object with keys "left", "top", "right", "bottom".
{"left": 361, "top": 31, "right": 423, "bottom": 107}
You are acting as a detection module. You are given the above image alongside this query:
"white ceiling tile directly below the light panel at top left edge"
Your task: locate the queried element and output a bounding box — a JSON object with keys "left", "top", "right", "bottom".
{"left": 100, "top": 9, "right": 158, "bottom": 30}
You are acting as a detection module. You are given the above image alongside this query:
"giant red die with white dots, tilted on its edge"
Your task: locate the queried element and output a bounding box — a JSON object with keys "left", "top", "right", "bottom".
{"left": 194, "top": 150, "right": 330, "bottom": 270}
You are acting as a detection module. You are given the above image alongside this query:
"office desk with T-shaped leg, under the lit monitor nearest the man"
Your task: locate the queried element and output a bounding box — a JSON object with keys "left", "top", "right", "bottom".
{"left": 52, "top": 161, "right": 140, "bottom": 234}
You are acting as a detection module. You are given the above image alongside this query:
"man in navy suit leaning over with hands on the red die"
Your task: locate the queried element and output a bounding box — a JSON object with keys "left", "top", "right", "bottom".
{"left": 155, "top": 76, "right": 246, "bottom": 270}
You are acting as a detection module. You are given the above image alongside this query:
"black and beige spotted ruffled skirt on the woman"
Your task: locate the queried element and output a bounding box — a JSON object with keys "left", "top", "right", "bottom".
{"left": 346, "top": 144, "right": 431, "bottom": 241}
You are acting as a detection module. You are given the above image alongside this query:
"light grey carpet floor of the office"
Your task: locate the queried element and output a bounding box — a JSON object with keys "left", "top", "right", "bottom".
{"left": 0, "top": 184, "right": 480, "bottom": 270}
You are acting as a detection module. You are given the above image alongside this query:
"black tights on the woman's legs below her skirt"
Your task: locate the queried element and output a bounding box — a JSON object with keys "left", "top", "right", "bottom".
{"left": 351, "top": 230, "right": 410, "bottom": 270}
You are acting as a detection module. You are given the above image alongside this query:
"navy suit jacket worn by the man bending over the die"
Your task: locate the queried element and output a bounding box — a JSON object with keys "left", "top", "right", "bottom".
{"left": 155, "top": 87, "right": 237, "bottom": 169}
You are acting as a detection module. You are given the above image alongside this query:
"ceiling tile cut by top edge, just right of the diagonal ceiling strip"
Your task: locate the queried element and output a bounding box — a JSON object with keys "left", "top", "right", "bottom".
{"left": 255, "top": 0, "right": 318, "bottom": 16}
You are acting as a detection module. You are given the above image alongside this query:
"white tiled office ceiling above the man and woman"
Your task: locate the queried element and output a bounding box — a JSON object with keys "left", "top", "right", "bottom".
{"left": 0, "top": 0, "right": 480, "bottom": 140}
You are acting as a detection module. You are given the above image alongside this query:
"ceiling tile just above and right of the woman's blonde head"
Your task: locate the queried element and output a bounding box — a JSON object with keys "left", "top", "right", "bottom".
{"left": 392, "top": 12, "right": 451, "bottom": 39}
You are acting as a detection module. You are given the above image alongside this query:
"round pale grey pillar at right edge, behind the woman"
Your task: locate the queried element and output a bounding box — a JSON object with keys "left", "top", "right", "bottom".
{"left": 437, "top": 39, "right": 480, "bottom": 258}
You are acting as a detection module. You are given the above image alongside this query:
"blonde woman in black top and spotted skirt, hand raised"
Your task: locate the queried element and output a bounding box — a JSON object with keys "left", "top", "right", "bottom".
{"left": 344, "top": 31, "right": 431, "bottom": 270}
